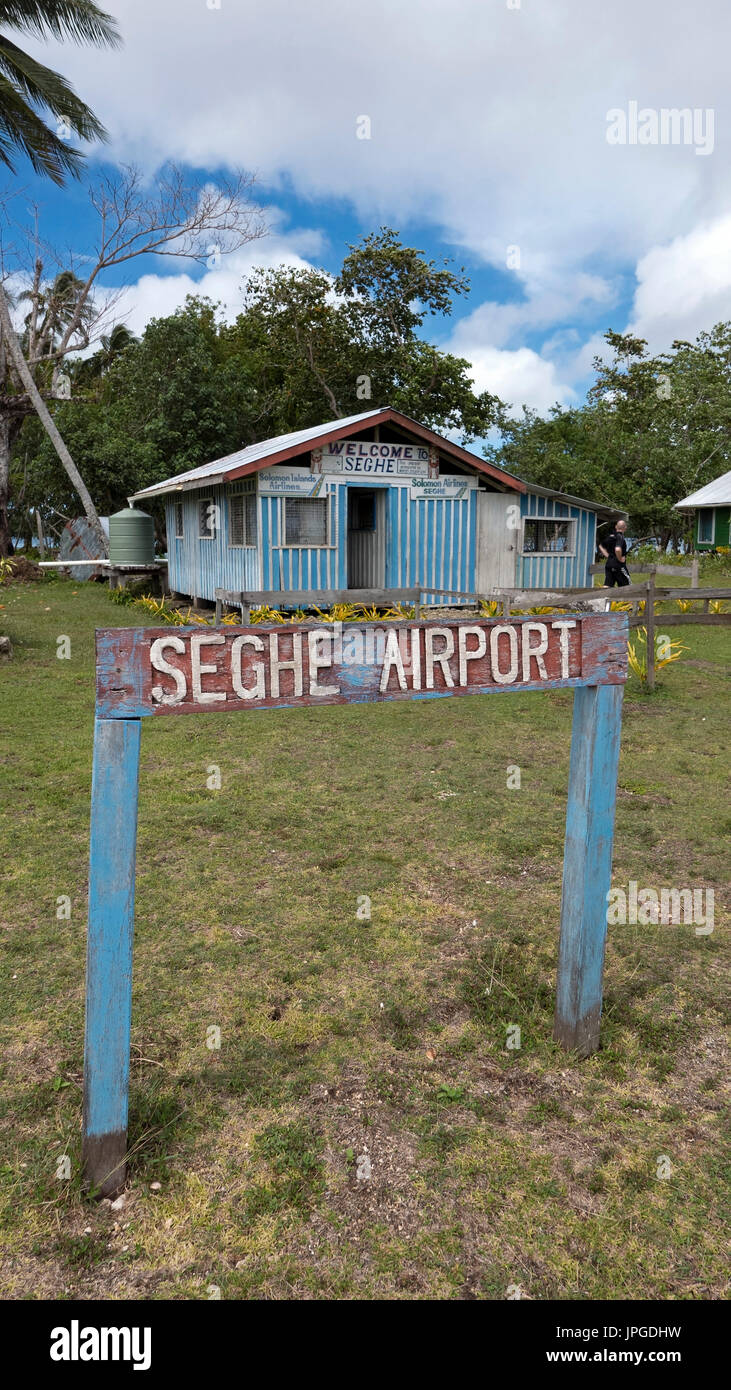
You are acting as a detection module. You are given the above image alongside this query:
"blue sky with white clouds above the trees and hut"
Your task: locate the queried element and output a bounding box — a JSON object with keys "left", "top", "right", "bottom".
{"left": 7, "top": 0, "right": 731, "bottom": 413}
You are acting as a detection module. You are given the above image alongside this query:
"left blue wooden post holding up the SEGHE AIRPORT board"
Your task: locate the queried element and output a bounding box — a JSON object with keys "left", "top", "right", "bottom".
{"left": 83, "top": 719, "right": 140, "bottom": 1197}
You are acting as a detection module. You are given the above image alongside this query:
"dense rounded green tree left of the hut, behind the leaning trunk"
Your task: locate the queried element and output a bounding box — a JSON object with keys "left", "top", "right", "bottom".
{"left": 11, "top": 296, "right": 256, "bottom": 535}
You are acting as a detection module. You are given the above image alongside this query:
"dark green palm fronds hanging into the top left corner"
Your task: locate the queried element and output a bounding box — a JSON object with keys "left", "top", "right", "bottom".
{"left": 0, "top": 0, "right": 121, "bottom": 183}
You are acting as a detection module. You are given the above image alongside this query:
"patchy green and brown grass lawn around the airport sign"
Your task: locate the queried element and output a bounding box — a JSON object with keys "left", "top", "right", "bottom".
{"left": 0, "top": 581, "right": 731, "bottom": 1300}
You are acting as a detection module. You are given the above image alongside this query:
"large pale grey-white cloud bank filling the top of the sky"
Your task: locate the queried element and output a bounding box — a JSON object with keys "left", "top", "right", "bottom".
{"left": 36, "top": 0, "right": 731, "bottom": 265}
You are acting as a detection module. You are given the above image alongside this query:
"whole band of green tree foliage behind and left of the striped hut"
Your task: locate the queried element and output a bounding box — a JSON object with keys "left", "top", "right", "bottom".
{"left": 11, "top": 228, "right": 502, "bottom": 539}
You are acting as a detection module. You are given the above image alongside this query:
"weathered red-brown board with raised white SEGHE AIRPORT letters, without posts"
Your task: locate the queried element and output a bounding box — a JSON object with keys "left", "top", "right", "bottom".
{"left": 96, "top": 613, "right": 627, "bottom": 719}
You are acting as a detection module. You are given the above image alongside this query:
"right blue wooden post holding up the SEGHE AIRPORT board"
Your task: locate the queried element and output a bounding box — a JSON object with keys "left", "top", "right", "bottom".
{"left": 553, "top": 685, "right": 624, "bottom": 1056}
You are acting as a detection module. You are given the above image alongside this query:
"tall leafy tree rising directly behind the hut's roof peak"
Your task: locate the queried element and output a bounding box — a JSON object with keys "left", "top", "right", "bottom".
{"left": 228, "top": 228, "right": 502, "bottom": 439}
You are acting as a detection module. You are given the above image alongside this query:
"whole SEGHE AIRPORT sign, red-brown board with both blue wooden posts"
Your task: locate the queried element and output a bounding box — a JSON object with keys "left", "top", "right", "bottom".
{"left": 83, "top": 613, "right": 628, "bottom": 1195}
